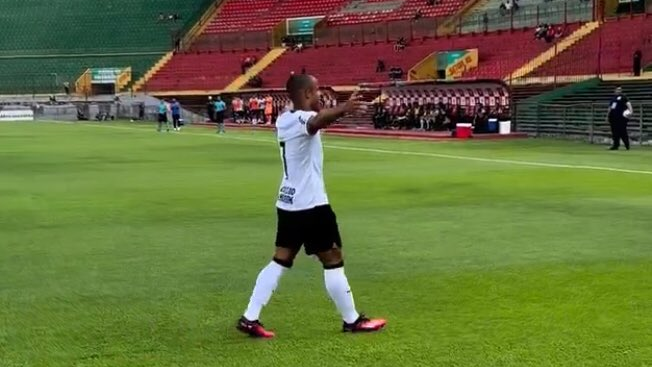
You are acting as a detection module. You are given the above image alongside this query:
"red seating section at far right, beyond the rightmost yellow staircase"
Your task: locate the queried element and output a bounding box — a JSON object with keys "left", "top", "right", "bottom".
{"left": 529, "top": 16, "right": 652, "bottom": 76}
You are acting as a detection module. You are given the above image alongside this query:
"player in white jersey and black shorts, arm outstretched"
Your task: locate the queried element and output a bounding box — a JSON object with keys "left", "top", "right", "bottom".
{"left": 237, "top": 75, "right": 386, "bottom": 338}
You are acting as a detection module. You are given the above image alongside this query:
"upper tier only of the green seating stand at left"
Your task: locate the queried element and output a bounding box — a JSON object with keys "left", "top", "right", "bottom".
{"left": 0, "top": 0, "right": 212, "bottom": 55}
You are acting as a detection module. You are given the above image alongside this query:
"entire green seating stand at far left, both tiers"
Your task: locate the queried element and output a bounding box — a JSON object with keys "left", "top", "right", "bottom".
{"left": 0, "top": 0, "right": 213, "bottom": 93}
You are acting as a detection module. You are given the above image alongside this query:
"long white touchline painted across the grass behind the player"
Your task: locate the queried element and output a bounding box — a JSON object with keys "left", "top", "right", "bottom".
{"left": 59, "top": 124, "right": 652, "bottom": 175}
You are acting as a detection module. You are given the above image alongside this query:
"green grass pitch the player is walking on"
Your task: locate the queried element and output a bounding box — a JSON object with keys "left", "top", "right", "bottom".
{"left": 0, "top": 123, "right": 652, "bottom": 367}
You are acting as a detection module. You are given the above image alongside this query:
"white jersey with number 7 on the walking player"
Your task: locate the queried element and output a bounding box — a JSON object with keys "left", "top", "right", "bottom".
{"left": 276, "top": 111, "right": 328, "bottom": 211}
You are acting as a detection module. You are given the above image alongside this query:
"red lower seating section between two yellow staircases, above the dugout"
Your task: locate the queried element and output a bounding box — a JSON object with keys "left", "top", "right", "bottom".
{"left": 261, "top": 25, "right": 576, "bottom": 87}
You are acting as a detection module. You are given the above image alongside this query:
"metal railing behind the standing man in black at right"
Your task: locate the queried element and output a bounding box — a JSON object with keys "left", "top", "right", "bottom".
{"left": 513, "top": 102, "right": 652, "bottom": 145}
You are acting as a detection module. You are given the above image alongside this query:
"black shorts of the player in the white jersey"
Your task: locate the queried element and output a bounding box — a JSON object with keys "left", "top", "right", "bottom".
{"left": 276, "top": 205, "right": 342, "bottom": 255}
